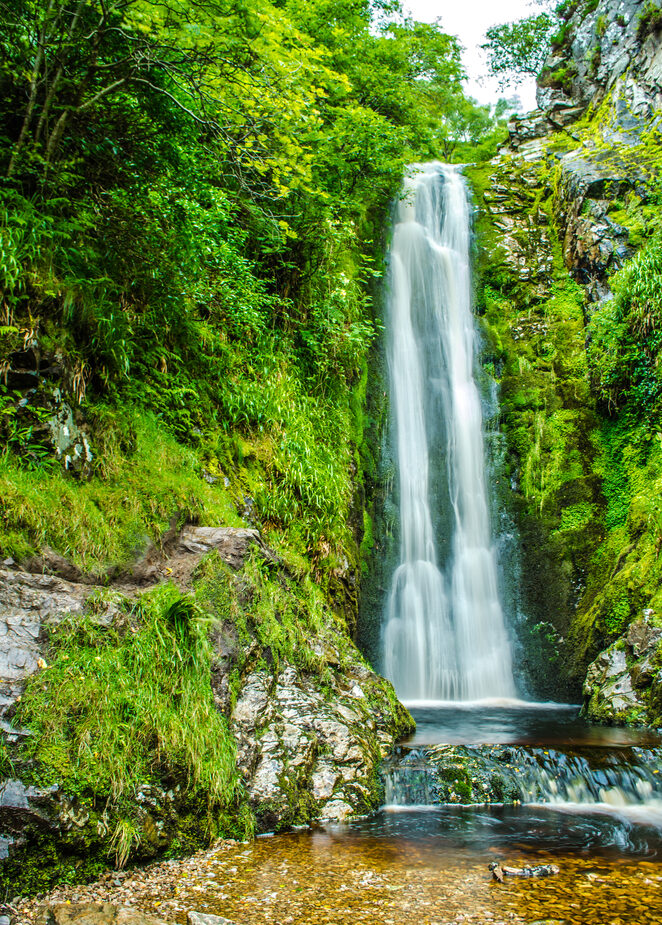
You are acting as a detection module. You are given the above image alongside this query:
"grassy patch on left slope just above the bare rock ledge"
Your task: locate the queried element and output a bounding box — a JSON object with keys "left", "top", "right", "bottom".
{"left": 0, "top": 407, "right": 242, "bottom": 571}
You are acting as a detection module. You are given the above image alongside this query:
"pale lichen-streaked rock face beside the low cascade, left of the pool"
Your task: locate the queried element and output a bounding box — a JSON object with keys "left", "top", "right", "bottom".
{"left": 232, "top": 664, "right": 406, "bottom": 828}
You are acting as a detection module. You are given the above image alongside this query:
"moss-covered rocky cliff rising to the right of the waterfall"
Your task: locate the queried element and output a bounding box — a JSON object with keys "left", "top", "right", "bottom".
{"left": 469, "top": 0, "right": 662, "bottom": 722}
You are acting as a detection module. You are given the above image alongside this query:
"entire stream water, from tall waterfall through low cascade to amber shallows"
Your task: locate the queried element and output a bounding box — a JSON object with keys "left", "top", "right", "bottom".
{"left": 144, "top": 164, "right": 662, "bottom": 925}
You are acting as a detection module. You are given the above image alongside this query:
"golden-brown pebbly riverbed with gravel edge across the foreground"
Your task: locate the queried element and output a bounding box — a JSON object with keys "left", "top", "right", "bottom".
{"left": 19, "top": 816, "right": 662, "bottom": 925}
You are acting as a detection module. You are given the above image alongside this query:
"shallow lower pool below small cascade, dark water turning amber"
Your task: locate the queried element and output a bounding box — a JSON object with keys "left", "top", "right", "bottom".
{"left": 128, "top": 807, "right": 662, "bottom": 925}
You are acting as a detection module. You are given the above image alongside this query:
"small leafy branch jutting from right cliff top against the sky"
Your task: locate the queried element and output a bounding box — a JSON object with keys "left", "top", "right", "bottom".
{"left": 481, "top": 13, "right": 555, "bottom": 86}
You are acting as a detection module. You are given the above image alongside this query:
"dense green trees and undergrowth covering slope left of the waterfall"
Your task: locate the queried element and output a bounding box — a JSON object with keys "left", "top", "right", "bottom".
{"left": 0, "top": 0, "right": 502, "bottom": 567}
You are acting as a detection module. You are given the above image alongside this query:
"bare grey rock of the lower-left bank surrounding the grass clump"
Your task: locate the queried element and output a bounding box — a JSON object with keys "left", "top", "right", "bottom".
{"left": 0, "top": 525, "right": 413, "bottom": 888}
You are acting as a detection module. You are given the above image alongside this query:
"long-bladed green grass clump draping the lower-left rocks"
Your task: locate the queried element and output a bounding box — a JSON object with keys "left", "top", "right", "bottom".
{"left": 20, "top": 586, "right": 252, "bottom": 864}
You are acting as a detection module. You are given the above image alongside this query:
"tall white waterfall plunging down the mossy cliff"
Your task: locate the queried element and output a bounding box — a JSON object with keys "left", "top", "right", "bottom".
{"left": 383, "top": 163, "right": 515, "bottom": 700}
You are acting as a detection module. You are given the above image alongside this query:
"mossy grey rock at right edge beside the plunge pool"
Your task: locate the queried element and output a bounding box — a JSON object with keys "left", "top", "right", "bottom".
{"left": 583, "top": 614, "right": 662, "bottom": 724}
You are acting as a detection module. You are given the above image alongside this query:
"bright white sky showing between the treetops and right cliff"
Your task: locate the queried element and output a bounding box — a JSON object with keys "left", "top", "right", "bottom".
{"left": 403, "top": 0, "right": 540, "bottom": 112}
